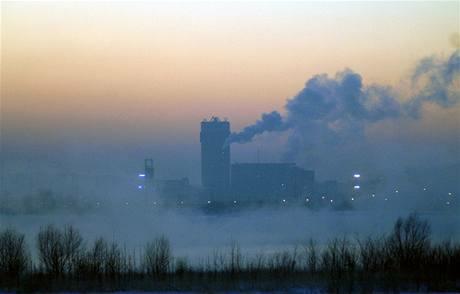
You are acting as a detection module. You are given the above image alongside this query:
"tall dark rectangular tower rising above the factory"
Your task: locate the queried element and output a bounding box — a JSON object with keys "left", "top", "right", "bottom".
{"left": 200, "top": 117, "right": 230, "bottom": 192}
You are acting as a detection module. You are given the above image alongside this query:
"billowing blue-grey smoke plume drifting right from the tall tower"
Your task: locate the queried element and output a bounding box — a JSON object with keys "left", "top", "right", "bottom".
{"left": 229, "top": 50, "right": 460, "bottom": 177}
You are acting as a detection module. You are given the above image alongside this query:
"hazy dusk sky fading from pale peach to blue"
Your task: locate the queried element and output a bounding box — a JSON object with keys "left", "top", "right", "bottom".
{"left": 1, "top": 1, "right": 460, "bottom": 183}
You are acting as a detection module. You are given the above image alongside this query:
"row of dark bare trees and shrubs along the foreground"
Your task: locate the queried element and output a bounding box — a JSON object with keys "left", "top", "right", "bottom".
{"left": 0, "top": 214, "right": 460, "bottom": 289}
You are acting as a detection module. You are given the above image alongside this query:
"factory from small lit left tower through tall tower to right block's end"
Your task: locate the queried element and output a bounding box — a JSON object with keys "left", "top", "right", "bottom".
{"left": 138, "top": 117, "right": 315, "bottom": 205}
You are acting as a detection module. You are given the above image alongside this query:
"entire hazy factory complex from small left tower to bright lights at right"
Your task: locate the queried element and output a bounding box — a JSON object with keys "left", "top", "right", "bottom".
{"left": 134, "top": 117, "right": 392, "bottom": 209}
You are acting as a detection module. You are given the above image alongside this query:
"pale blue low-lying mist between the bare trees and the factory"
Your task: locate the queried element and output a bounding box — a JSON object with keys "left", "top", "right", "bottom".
{"left": 1, "top": 192, "right": 460, "bottom": 261}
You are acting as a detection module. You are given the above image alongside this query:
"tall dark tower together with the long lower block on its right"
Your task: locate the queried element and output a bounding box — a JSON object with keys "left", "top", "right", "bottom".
{"left": 200, "top": 117, "right": 315, "bottom": 201}
